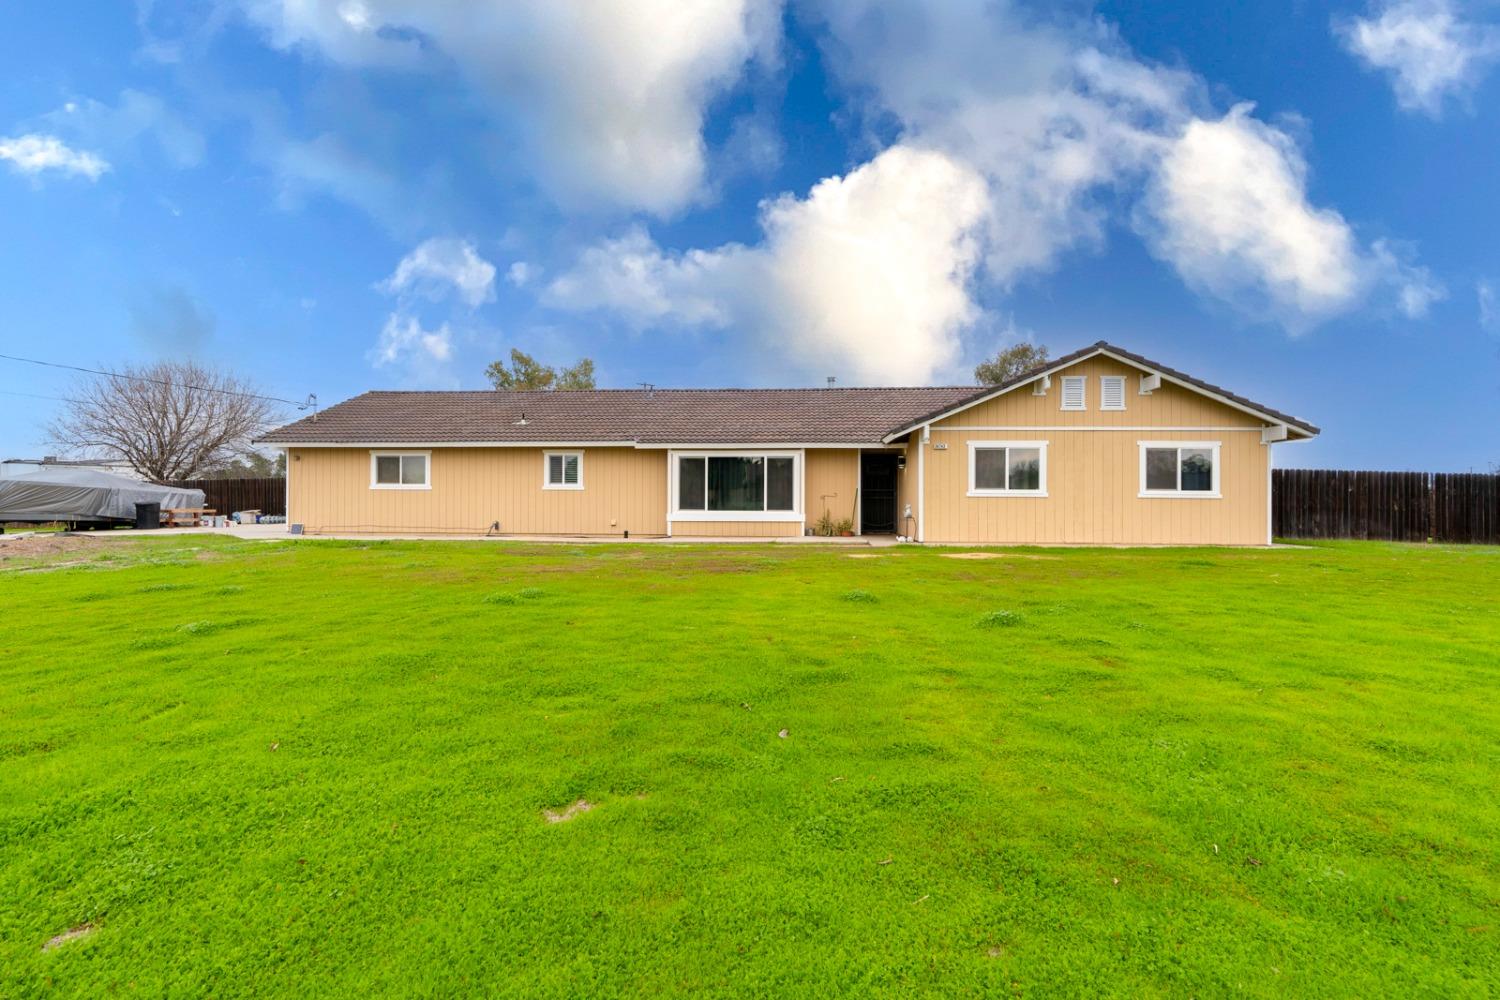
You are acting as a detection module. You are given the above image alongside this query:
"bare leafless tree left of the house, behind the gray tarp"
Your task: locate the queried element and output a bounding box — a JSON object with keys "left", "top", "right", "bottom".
{"left": 50, "top": 361, "right": 279, "bottom": 483}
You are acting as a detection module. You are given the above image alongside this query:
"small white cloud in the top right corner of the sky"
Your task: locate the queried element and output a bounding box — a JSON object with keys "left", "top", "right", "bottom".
{"left": 1334, "top": 0, "right": 1500, "bottom": 117}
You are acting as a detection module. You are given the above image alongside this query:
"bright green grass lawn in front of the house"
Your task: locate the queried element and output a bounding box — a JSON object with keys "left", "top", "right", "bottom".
{"left": 0, "top": 537, "right": 1500, "bottom": 997}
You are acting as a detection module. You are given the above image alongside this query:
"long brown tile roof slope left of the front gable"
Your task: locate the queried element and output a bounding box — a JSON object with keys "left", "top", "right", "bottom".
{"left": 260, "top": 385, "right": 975, "bottom": 444}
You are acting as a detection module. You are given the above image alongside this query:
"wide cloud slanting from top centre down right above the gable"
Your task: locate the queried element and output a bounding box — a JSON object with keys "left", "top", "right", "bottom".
{"left": 822, "top": 0, "right": 1436, "bottom": 330}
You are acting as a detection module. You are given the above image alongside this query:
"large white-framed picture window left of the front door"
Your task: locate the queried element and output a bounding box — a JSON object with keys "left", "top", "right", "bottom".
{"left": 671, "top": 451, "right": 803, "bottom": 520}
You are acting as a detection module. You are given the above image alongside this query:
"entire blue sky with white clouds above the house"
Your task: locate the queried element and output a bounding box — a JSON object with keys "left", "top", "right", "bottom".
{"left": 0, "top": 0, "right": 1500, "bottom": 471}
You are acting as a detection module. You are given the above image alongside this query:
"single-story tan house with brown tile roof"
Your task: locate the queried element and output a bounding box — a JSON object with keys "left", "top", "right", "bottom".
{"left": 260, "top": 342, "right": 1319, "bottom": 546}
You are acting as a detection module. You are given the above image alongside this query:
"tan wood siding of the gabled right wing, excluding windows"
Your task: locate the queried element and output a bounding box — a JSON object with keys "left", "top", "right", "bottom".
{"left": 930, "top": 358, "right": 1271, "bottom": 544}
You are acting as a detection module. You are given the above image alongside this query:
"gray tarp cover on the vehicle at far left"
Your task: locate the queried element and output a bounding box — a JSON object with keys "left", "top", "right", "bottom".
{"left": 0, "top": 468, "right": 203, "bottom": 522}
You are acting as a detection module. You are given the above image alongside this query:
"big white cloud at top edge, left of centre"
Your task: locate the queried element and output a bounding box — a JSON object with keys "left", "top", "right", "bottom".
{"left": 243, "top": 0, "right": 780, "bottom": 213}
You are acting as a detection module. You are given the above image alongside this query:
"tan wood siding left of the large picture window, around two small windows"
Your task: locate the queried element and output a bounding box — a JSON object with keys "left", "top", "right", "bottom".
{"left": 288, "top": 448, "right": 666, "bottom": 535}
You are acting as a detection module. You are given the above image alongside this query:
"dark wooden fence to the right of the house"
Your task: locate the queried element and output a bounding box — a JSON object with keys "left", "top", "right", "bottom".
{"left": 1271, "top": 469, "right": 1500, "bottom": 543}
